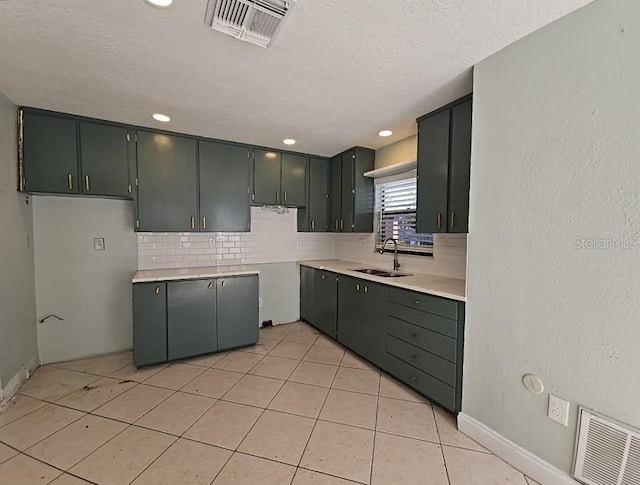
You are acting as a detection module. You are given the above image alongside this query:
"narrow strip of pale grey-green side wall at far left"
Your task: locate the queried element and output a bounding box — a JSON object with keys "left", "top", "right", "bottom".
{"left": 0, "top": 93, "right": 38, "bottom": 402}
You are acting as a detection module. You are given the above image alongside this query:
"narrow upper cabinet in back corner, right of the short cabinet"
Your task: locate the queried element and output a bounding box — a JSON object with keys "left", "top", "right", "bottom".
{"left": 298, "top": 157, "right": 330, "bottom": 232}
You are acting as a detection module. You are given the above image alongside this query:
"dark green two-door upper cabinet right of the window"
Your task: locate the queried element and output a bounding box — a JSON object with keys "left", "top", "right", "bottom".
{"left": 416, "top": 96, "right": 472, "bottom": 233}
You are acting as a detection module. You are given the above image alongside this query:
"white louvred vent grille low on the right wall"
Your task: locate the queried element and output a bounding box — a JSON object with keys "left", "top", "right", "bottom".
{"left": 573, "top": 408, "right": 640, "bottom": 485}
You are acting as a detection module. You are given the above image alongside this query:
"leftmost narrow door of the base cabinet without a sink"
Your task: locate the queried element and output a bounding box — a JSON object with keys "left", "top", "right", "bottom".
{"left": 133, "top": 281, "right": 167, "bottom": 367}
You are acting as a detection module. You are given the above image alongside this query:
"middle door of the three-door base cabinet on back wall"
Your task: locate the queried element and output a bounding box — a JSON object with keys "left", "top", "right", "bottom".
{"left": 167, "top": 280, "right": 218, "bottom": 360}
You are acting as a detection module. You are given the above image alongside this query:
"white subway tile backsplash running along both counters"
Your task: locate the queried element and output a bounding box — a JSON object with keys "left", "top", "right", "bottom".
{"left": 138, "top": 207, "right": 467, "bottom": 279}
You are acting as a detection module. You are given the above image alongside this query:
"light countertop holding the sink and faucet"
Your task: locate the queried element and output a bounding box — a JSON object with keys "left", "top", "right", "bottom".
{"left": 299, "top": 259, "right": 467, "bottom": 301}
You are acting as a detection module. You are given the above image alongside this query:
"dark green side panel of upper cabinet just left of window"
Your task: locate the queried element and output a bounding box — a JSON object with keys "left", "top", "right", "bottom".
{"left": 353, "top": 148, "right": 375, "bottom": 233}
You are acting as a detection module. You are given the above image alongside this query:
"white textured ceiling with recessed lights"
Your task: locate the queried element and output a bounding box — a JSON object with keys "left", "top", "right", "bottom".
{"left": 0, "top": 0, "right": 590, "bottom": 155}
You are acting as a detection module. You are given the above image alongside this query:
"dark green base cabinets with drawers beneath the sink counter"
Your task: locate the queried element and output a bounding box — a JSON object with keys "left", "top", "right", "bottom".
{"left": 300, "top": 266, "right": 465, "bottom": 412}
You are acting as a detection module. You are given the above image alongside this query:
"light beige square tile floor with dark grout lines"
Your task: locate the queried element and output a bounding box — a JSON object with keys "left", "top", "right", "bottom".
{"left": 0, "top": 322, "right": 535, "bottom": 485}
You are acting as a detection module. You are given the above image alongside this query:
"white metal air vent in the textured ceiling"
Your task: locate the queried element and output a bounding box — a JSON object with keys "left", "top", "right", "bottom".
{"left": 204, "top": 0, "right": 296, "bottom": 47}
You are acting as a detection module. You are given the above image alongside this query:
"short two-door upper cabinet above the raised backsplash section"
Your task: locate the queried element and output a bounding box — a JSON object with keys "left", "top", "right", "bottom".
{"left": 252, "top": 148, "right": 307, "bottom": 207}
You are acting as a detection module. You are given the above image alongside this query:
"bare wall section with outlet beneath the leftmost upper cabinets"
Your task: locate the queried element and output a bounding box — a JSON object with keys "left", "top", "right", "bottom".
{"left": 33, "top": 196, "right": 137, "bottom": 363}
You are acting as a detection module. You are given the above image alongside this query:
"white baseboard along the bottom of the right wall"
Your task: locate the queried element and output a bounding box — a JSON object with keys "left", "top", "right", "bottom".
{"left": 458, "top": 413, "right": 580, "bottom": 485}
